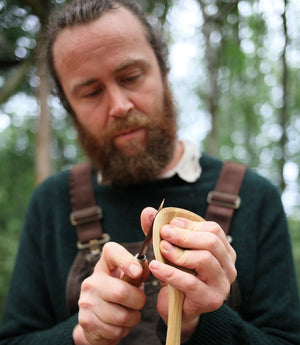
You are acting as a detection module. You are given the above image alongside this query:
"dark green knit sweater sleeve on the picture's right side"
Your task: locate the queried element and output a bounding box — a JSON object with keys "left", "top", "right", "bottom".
{"left": 186, "top": 176, "right": 300, "bottom": 345}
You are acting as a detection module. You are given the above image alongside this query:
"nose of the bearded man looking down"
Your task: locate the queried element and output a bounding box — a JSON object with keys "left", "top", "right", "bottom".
{"left": 107, "top": 86, "right": 133, "bottom": 117}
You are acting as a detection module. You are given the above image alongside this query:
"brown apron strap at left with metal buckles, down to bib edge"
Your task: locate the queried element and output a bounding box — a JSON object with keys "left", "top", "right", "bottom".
{"left": 66, "top": 162, "right": 110, "bottom": 314}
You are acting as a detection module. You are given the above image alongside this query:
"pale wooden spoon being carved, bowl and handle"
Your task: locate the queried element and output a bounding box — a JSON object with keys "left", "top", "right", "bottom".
{"left": 153, "top": 207, "right": 204, "bottom": 345}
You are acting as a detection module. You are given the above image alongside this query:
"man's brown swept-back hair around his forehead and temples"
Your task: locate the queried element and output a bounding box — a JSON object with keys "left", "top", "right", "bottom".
{"left": 46, "top": 0, "right": 169, "bottom": 114}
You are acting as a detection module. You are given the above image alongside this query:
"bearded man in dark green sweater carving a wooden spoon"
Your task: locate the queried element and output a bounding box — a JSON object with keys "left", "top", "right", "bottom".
{"left": 0, "top": 0, "right": 300, "bottom": 345}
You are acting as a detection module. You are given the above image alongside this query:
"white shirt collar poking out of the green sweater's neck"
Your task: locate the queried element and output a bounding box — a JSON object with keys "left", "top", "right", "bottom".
{"left": 98, "top": 140, "right": 202, "bottom": 184}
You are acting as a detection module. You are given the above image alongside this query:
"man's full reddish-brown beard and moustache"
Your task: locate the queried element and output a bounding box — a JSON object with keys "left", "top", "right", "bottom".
{"left": 75, "top": 86, "right": 177, "bottom": 186}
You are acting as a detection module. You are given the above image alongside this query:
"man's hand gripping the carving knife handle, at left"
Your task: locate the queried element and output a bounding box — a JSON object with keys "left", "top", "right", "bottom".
{"left": 73, "top": 242, "right": 146, "bottom": 345}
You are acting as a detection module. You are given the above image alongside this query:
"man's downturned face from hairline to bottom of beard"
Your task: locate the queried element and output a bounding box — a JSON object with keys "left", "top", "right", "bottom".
{"left": 53, "top": 8, "right": 176, "bottom": 184}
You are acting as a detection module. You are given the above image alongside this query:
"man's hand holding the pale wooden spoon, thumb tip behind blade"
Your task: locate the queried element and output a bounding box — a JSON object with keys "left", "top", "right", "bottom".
{"left": 141, "top": 208, "right": 237, "bottom": 340}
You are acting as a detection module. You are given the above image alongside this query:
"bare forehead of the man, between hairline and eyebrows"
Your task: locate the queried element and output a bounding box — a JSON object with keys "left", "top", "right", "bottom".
{"left": 53, "top": 7, "right": 154, "bottom": 72}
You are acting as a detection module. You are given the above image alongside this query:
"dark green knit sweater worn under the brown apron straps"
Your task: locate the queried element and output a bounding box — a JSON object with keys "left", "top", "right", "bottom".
{"left": 0, "top": 155, "right": 300, "bottom": 345}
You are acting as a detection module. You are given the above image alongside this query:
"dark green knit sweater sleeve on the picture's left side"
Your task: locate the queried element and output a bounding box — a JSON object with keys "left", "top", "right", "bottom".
{"left": 0, "top": 181, "right": 78, "bottom": 345}
